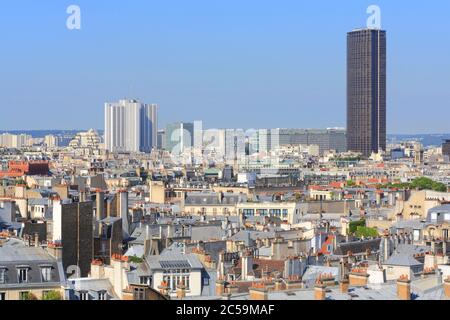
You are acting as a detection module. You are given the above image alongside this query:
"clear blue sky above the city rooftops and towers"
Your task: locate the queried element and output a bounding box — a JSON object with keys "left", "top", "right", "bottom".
{"left": 0, "top": 0, "right": 450, "bottom": 133}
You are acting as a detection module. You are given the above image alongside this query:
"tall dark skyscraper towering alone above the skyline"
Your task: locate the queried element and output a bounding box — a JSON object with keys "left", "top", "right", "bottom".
{"left": 347, "top": 29, "right": 386, "bottom": 156}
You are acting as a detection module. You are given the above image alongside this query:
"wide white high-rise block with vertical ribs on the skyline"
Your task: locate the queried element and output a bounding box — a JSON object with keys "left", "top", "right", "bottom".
{"left": 105, "top": 100, "right": 158, "bottom": 152}
